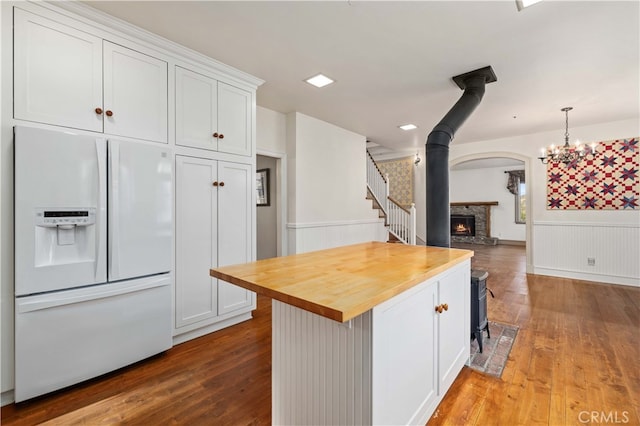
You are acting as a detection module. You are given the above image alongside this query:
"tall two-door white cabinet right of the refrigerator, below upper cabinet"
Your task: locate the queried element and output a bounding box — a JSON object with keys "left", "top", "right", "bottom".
{"left": 174, "top": 155, "right": 256, "bottom": 335}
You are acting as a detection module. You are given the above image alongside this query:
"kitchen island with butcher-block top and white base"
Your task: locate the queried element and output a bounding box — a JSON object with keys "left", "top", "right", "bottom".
{"left": 210, "top": 242, "right": 473, "bottom": 424}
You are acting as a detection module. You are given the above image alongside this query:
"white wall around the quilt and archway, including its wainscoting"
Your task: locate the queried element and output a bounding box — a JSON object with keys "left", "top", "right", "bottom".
{"left": 444, "top": 119, "right": 640, "bottom": 286}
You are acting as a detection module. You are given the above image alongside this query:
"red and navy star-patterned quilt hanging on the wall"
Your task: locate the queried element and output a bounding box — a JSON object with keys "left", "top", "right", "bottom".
{"left": 547, "top": 137, "right": 640, "bottom": 210}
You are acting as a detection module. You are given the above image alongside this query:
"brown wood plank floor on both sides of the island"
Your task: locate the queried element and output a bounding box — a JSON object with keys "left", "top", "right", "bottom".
{"left": 1, "top": 246, "right": 640, "bottom": 425}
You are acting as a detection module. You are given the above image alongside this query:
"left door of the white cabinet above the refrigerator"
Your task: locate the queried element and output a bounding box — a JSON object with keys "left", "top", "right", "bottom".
{"left": 13, "top": 8, "right": 102, "bottom": 132}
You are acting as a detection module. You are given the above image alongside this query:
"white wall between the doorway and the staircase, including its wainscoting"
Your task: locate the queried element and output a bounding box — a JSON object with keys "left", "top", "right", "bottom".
{"left": 287, "top": 112, "right": 385, "bottom": 253}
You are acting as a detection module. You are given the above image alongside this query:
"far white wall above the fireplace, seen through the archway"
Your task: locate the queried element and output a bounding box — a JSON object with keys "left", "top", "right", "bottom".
{"left": 449, "top": 167, "right": 526, "bottom": 241}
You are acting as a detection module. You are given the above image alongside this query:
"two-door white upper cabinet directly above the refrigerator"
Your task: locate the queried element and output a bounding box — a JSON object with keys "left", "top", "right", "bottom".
{"left": 14, "top": 8, "right": 168, "bottom": 143}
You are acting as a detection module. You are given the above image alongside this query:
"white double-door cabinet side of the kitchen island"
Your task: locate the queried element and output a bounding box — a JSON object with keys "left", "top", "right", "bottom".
{"left": 372, "top": 261, "right": 471, "bottom": 424}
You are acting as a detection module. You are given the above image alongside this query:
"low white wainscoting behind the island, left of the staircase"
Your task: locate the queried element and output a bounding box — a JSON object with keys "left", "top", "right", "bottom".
{"left": 287, "top": 219, "right": 388, "bottom": 254}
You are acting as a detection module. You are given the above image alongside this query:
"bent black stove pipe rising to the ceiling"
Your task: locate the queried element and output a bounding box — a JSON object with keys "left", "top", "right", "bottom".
{"left": 425, "top": 66, "right": 496, "bottom": 247}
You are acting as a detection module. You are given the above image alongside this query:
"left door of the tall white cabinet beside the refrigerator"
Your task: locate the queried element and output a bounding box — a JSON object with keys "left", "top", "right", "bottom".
{"left": 175, "top": 155, "right": 218, "bottom": 328}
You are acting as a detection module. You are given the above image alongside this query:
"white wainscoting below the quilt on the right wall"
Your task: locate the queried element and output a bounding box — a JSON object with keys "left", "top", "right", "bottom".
{"left": 533, "top": 222, "right": 640, "bottom": 287}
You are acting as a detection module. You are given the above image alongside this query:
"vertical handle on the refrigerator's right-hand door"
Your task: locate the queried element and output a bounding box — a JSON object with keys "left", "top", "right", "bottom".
{"left": 108, "top": 140, "right": 120, "bottom": 281}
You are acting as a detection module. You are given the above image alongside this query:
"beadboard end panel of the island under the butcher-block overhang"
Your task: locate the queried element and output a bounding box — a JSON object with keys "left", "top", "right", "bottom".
{"left": 271, "top": 299, "right": 371, "bottom": 425}
